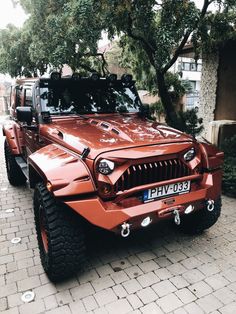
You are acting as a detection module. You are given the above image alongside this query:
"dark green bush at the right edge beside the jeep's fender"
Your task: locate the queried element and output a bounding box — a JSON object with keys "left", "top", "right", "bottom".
{"left": 221, "top": 135, "right": 236, "bottom": 197}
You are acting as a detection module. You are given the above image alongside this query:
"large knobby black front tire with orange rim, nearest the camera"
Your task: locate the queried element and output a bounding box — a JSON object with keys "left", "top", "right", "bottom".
{"left": 34, "top": 183, "right": 86, "bottom": 282}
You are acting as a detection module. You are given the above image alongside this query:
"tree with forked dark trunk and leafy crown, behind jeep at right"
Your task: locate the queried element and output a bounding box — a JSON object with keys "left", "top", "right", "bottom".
{"left": 98, "top": 0, "right": 236, "bottom": 129}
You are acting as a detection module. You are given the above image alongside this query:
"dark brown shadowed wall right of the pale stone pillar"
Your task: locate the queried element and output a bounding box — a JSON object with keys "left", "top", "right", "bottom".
{"left": 215, "top": 41, "right": 236, "bottom": 120}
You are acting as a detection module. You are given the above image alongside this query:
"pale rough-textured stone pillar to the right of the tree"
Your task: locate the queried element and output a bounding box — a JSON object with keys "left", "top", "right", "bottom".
{"left": 199, "top": 53, "right": 219, "bottom": 137}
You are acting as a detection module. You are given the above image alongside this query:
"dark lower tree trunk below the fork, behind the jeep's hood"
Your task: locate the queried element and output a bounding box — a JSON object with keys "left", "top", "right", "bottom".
{"left": 156, "top": 69, "right": 182, "bottom": 130}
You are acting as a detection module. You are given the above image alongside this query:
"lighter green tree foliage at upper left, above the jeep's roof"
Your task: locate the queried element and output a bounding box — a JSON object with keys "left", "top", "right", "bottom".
{"left": 0, "top": 0, "right": 104, "bottom": 76}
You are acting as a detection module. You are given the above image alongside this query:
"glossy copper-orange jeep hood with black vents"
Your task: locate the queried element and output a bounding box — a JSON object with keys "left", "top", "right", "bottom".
{"left": 41, "top": 114, "right": 193, "bottom": 159}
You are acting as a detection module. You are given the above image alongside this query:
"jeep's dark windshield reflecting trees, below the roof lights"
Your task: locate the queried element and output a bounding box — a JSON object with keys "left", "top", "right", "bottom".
{"left": 40, "top": 78, "right": 141, "bottom": 115}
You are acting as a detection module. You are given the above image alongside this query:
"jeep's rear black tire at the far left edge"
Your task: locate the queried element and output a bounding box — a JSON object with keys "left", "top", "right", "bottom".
{"left": 4, "top": 140, "right": 26, "bottom": 186}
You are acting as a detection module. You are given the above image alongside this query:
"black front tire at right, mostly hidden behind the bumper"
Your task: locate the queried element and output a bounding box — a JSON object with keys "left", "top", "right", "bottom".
{"left": 178, "top": 198, "right": 221, "bottom": 234}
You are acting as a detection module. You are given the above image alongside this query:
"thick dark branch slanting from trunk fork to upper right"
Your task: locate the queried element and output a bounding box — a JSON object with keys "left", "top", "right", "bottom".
{"left": 162, "top": 0, "right": 214, "bottom": 73}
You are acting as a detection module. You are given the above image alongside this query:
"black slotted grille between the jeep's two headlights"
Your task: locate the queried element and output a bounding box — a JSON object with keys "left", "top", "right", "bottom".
{"left": 115, "top": 159, "right": 192, "bottom": 193}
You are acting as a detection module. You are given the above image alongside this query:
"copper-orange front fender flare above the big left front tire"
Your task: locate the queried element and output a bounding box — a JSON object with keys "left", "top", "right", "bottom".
{"left": 28, "top": 144, "right": 96, "bottom": 197}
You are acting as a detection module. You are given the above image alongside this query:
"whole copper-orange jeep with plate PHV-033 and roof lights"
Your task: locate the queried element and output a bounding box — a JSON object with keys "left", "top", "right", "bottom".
{"left": 3, "top": 72, "right": 223, "bottom": 281}
